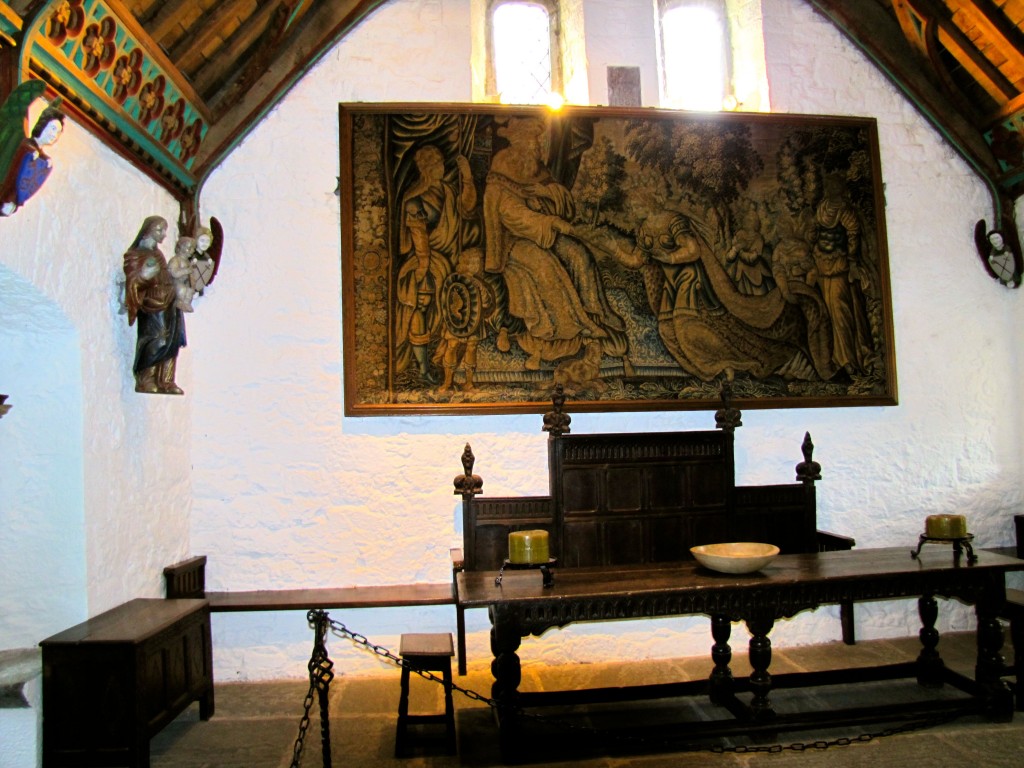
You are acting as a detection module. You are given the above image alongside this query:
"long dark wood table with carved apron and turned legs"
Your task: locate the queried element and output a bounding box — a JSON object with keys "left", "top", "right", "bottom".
{"left": 458, "top": 547, "right": 1024, "bottom": 760}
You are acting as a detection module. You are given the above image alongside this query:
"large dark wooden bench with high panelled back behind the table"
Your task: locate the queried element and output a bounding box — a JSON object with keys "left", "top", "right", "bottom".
{"left": 453, "top": 388, "right": 854, "bottom": 675}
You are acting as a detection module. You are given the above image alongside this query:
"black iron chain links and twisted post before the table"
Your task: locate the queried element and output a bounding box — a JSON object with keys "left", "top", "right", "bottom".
{"left": 291, "top": 611, "right": 959, "bottom": 768}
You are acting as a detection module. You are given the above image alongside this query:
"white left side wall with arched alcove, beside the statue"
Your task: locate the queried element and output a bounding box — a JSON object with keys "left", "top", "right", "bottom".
{"left": 0, "top": 112, "right": 191, "bottom": 630}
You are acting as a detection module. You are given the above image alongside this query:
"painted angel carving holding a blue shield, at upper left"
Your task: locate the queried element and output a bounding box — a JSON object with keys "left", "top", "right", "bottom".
{"left": 0, "top": 80, "right": 65, "bottom": 216}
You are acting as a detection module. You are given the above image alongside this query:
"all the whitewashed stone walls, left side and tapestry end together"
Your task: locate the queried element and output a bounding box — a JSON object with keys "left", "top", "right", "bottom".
{"left": 0, "top": 0, "right": 1024, "bottom": 696}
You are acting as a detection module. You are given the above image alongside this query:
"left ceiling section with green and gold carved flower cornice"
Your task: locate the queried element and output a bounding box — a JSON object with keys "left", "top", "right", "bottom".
{"left": 0, "top": 0, "right": 384, "bottom": 203}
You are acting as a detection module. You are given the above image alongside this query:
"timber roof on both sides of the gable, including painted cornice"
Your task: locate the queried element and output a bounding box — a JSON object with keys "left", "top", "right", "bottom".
{"left": 0, "top": 0, "right": 1024, "bottom": 227}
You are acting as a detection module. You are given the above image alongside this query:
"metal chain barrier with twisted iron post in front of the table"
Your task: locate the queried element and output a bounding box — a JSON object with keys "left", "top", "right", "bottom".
{"left": 291, "top": 610, "right": 959, "bottom": 768}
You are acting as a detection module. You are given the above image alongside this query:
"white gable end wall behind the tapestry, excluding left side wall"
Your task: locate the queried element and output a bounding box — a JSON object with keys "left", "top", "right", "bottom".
{"left": 188, "top": 0, "right": 1022, "bottom": 680}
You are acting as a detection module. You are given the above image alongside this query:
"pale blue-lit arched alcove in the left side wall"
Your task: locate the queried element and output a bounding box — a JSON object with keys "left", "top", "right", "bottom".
{"left": 0, "top": 265, "right": 86, "bottom": 649}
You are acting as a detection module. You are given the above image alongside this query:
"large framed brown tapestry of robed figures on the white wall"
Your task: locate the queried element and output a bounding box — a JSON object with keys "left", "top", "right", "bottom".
{"left": 339, "top": 103, "right": 897, "bottom": 416}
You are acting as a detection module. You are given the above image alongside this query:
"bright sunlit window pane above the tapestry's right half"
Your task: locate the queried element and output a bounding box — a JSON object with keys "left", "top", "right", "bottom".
{"left": 662, "top": 6, "right": 725, "bottom": 112}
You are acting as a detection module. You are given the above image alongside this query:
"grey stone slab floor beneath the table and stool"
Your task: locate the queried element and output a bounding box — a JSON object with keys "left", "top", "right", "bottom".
{"left": 152, "top": 634, "right": 1024, "bottom": 768}
